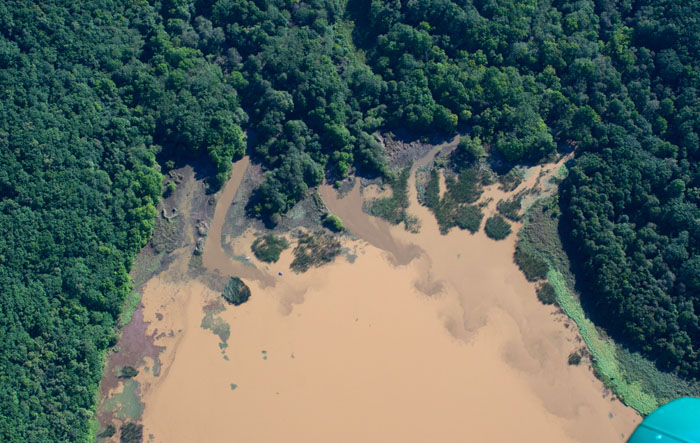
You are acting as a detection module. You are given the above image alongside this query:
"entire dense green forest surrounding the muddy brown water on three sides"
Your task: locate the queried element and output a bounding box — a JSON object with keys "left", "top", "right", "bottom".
{"left": 0, "top": 0, "right": 700, "bottom": 441}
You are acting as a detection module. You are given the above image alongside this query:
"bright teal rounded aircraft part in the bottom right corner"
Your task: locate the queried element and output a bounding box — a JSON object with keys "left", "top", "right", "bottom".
{"left": 628, "top": 397, "right": 700, "bottom": 443}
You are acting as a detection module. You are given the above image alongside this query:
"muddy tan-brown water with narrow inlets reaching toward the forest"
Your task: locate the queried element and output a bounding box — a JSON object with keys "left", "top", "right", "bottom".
{"left": 131, "top": 152, "right": 639, "bottom": 442}
